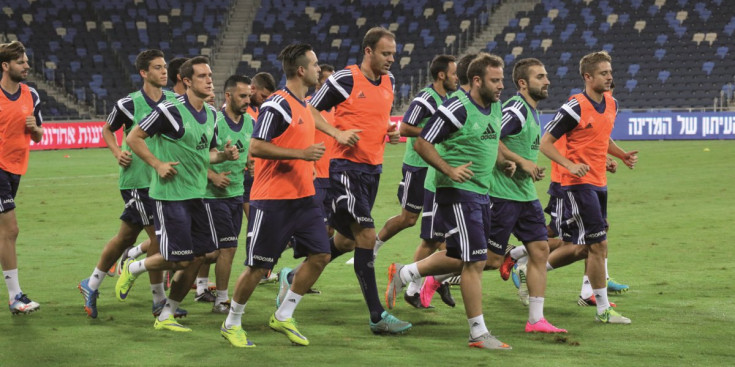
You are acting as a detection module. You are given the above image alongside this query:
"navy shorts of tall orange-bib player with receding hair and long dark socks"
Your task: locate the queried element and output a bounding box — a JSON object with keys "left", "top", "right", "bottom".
{"left": 329, "top": 171, "right": 380, "bottom": 240}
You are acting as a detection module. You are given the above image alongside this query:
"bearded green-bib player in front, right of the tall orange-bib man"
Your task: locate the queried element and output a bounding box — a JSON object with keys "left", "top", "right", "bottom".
{"left": 412, "top": 53, "right": 511, "bottom": 349}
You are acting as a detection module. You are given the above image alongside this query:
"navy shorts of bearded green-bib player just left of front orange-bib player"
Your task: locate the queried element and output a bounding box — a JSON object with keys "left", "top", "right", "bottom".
{"left": 204, "top": 196, "right": 242, "bottom": 249}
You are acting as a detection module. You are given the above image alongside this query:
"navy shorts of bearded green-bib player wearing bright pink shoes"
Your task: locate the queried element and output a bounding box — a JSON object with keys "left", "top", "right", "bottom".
{"left": 488, "top": 198, "right": 548, "bottom": 254}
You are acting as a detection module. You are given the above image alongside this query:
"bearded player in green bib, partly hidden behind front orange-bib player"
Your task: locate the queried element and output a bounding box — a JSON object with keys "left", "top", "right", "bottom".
{"left": 206, "top": 75, "right": 253, "bottom": 313}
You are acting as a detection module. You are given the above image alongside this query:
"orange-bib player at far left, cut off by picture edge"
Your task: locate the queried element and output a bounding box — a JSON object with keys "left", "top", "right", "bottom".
{"left": 0, "top": 41, "right": 43, "bottom": 315}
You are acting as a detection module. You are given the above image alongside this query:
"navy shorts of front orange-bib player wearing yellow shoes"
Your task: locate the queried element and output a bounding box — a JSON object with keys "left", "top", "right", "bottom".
{"left": 245, "top": 196, "right": 331, "bottom": 269}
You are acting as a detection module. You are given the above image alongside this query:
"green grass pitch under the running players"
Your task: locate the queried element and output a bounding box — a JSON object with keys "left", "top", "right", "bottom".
{"left": 0, "top": 141, "right": 735, "bottom": 367}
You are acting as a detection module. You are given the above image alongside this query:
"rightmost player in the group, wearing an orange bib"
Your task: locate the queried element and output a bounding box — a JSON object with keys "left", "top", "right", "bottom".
{"left": 540, "top": 51, "right": 638, "bottom": 324}
